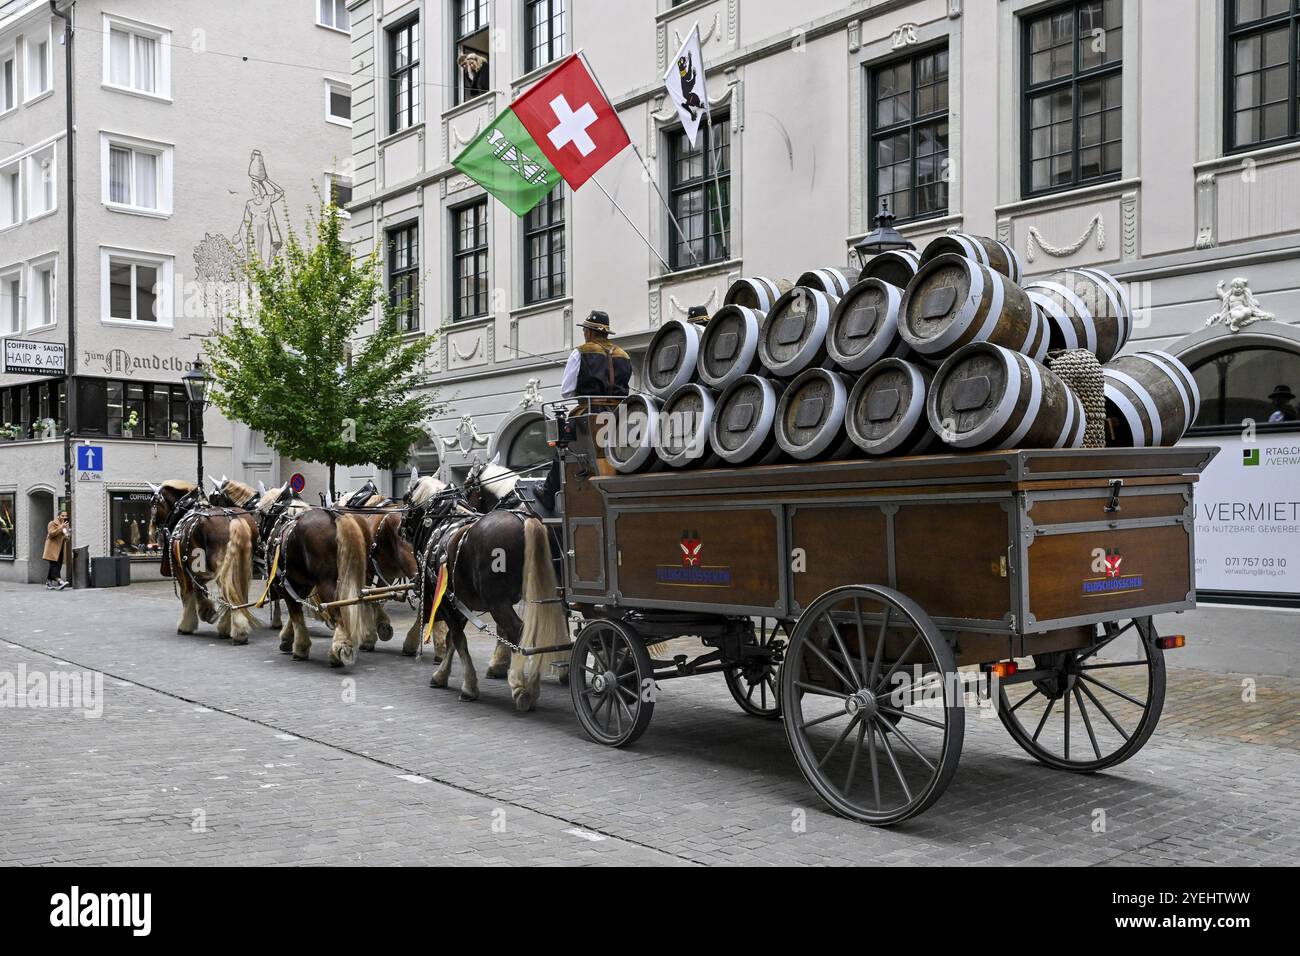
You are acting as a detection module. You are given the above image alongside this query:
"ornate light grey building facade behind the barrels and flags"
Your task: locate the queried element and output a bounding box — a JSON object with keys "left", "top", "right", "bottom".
{"left": 348, "top": 0, "right": 1300, "bottom": 592}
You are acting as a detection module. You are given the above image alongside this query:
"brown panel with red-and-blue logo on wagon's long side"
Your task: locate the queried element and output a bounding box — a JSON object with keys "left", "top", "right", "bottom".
{"left": 611, "top": 501, "right": 787, "bottom": 614}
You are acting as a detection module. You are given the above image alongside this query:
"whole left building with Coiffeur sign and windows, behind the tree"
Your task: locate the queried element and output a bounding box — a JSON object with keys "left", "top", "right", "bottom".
{"left": 0, "top": 0, "right": 351, "bottom": 580}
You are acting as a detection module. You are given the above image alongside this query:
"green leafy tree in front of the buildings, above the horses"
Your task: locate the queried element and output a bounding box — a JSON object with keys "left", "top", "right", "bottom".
{"left": 204, "top": 192, "right": 441, "bottom": 499}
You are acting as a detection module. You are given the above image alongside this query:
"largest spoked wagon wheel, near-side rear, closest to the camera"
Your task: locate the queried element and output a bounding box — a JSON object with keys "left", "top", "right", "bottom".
{"left": 781, "top": 585, "right": 966, "bottom": 825}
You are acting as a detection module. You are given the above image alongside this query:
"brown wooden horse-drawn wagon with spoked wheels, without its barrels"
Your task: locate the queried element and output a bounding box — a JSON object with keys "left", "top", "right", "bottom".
{"left": 553, "top": 412, "right": 1216, "bottom": 823}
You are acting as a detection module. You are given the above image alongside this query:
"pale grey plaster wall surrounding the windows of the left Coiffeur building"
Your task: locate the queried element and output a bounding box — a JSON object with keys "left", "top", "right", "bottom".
{"left": 0, "top": 0, "right": 352, "bottom": 580}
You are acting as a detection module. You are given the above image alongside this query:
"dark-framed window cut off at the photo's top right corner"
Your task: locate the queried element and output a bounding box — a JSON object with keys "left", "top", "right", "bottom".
{"left": 1225, "top": 0, "right": 1300, "bottom": 150}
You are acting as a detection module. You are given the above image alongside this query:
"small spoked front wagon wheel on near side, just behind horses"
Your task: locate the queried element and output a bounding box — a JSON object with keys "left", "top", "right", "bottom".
{"left": 569, "top": 620, "right": 654, "bottom": 747}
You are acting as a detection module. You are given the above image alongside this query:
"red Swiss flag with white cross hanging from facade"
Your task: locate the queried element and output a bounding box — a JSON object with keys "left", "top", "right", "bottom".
{"left": 511, "top": 53, "right": 631, "bottom": 189}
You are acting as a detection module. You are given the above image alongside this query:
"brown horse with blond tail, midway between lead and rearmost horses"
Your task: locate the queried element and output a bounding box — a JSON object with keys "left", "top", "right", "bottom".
{"left": 257, "top": 484, "right": 374, "bottom": 667}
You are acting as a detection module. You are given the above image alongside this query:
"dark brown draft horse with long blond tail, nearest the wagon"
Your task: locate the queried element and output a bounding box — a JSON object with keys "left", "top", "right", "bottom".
{"left": 402, "top": 477, "right": 568, "bottom": 711}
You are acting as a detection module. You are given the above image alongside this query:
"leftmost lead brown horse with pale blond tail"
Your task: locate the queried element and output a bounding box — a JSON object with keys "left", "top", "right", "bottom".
{"left": 150, "top": 479, "right": 257, "bottom": 644}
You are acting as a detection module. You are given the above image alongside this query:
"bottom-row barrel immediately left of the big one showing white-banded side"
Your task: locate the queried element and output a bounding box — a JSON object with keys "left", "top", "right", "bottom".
{"left": 845, "top": 359, "right": 941, "bottom": 455}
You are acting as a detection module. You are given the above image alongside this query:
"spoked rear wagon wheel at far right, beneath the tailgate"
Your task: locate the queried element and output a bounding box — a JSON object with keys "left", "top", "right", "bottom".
{"left": 997, "top": 618, "right": 1165, "bottom": 774}
